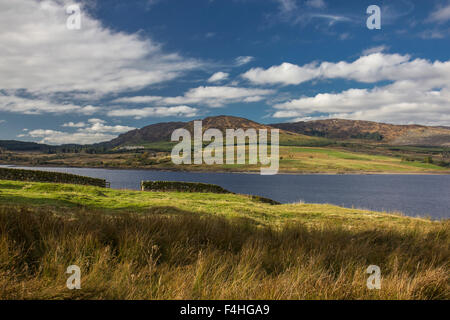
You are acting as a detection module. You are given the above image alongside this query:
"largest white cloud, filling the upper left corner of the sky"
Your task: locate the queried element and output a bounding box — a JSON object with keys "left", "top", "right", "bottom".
{"left": 0, "top": 0, "right": 201, "bottom": 102}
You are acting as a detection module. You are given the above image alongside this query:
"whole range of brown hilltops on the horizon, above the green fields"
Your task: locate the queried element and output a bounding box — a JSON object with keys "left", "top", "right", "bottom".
{"left": 4, "top": 115, "right": 450, "bottom": 152}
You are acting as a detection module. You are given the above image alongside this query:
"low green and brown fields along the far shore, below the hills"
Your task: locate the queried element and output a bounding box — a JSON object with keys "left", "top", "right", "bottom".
{"left": 0, "top": 146, "right": 450, "bottom": 174}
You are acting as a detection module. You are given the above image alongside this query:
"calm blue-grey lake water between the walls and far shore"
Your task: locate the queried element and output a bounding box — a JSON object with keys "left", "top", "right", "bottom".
{"left": 3, "top": 167, "right": 450, "bottom": 218}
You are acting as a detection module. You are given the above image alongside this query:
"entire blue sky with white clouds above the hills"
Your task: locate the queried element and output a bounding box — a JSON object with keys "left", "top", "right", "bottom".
{"left": 0, "top": 0, "right": 450, "bottom": 144}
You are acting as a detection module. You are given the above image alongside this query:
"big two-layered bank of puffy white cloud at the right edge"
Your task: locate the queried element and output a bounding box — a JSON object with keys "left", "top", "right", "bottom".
{"left": 273, "top": 53, "right": 450, "bottom": 125}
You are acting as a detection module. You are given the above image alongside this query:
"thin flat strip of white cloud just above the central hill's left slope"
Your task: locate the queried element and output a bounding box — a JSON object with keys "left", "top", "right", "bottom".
{"left": 108, "top": 106, "right": 198, "bottom": 119}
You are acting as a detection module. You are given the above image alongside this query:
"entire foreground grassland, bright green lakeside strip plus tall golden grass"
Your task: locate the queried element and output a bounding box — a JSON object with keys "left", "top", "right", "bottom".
{"left": 0, "top": 181, "right": 450, "bottom": 299}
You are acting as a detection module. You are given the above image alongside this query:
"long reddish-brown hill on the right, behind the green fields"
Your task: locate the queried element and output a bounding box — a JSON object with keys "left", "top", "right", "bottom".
{"left": 270, "top": 119, "right": 450, "bottom": 146}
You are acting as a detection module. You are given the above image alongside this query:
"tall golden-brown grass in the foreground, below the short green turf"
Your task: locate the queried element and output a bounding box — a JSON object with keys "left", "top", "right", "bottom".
{"left": 0, "top": 206, "right": 450, "bottom": 299}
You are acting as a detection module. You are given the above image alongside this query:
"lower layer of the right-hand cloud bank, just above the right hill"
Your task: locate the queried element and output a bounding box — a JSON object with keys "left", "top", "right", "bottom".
{"left": 273, "top": 81, "right": 450, "bottom": 125}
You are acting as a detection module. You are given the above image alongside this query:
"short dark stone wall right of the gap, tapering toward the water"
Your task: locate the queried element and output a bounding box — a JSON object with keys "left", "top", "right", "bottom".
{"left": 141, "top": 181, "right": 232, "bottom": 193}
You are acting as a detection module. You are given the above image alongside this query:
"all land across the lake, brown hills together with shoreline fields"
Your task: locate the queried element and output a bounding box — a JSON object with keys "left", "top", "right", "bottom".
{"left": 0, "top": 116, "right": 450, "bottom": 174}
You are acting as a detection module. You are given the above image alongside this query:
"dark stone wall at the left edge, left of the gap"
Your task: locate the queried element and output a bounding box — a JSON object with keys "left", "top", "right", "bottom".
{"left": 0, "top": 168, "right": 106, "bottom": 188}
